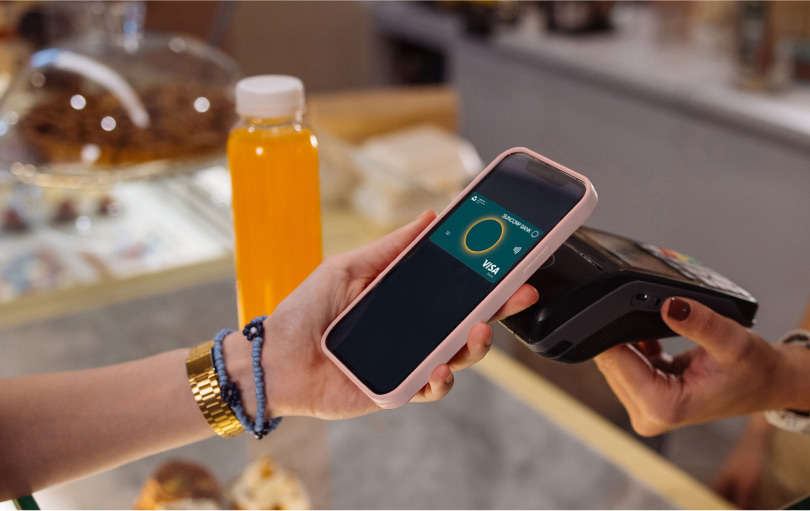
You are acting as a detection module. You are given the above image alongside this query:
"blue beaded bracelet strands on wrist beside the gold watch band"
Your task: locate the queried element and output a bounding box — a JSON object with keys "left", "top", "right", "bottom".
{"left": 211, "top": 316, "right": 281, "bottom": 440}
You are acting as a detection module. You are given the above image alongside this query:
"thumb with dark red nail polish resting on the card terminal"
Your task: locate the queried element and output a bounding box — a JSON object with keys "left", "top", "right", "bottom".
{"left": 661, "top": 297, "right": 747, "bottom": 362}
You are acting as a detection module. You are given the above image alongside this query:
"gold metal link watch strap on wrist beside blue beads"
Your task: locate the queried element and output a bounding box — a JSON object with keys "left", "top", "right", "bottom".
{"left": 186, "top": 341, "right": 245, "bottom": 438}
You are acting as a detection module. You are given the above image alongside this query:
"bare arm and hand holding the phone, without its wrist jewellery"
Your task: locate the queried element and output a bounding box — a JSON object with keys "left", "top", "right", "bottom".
{"left": 0, "top": 213, "right": 537, "bottom": 501}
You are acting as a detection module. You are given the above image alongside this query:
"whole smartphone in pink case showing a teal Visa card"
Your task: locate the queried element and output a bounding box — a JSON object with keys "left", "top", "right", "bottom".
{"left": 321, "top": 148, "right": 596, "bottom": 408}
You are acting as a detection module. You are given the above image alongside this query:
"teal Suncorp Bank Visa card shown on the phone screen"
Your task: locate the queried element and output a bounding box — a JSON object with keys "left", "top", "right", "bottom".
{"left": 430, "top": 193, "right": 543, "bottom": 282}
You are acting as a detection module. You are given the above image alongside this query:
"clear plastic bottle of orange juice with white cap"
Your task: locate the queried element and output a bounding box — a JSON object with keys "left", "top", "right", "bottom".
{"left": 228, "top": 75, "right": 322, "bottom": 324}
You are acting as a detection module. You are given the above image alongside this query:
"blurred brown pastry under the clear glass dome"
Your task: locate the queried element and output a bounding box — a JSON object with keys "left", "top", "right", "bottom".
{"left": 20, "top": 82, "right": 235, "bottom": 166}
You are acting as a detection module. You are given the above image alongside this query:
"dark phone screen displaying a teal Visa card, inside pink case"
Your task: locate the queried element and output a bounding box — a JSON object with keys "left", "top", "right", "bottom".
{"left": 326, "top": 153, "right": 585, "bottom": 394}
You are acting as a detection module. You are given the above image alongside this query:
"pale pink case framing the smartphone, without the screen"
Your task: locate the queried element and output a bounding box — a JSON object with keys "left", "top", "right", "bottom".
{"left": 321, "top": 147, "right": 596, "bottom": 408}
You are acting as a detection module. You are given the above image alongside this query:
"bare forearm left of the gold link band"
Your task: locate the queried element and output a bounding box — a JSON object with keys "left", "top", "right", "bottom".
{"left": 0, "top": 350, "right": 214, "bottom": 501}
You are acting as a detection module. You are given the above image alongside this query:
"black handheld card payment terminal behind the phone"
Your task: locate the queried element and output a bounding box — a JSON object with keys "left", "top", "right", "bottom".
{"left": 501, "top": 227, "right": 757, "bottom": 363}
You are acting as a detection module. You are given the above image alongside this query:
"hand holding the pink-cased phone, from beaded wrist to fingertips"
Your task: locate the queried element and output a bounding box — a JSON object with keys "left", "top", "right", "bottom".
{"left": 225, "top": 211, "right": 538, "bottom": 419}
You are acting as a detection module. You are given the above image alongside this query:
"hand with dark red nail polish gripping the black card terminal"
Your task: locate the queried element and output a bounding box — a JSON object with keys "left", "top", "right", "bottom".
{"left": 596, "top": 298, "right": 810, "bottom": 436}
